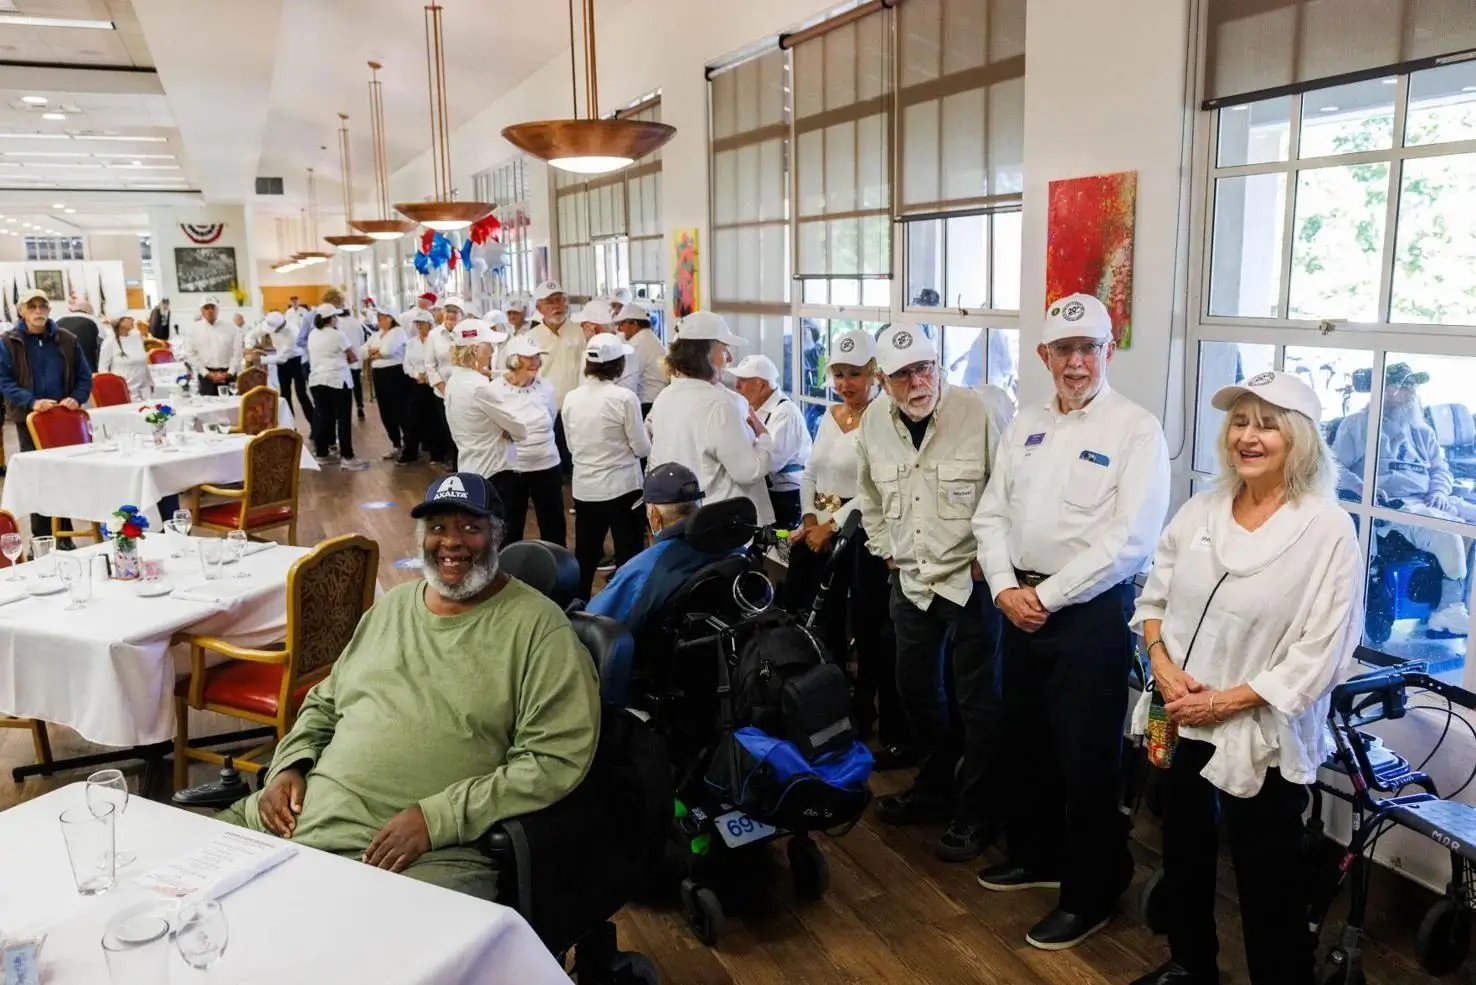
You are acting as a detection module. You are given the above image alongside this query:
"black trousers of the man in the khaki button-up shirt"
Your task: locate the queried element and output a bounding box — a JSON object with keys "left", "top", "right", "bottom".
{"left": 892, "top": 577, "right": 1003, "bottom": 821}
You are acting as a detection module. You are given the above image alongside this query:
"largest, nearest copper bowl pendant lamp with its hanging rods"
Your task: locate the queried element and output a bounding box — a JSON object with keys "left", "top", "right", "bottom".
{"left": 502, "top": 0, "right": 676, "bottom": 174}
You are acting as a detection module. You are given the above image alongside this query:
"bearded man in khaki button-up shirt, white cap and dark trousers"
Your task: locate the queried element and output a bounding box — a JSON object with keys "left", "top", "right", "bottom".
{"left": 858, "top": 325, "right": 1014, "bottom": 861}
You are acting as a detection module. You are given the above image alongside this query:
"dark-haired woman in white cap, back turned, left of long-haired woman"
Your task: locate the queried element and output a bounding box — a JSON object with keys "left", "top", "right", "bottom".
{"left": 562, "top": 332, "right": 651, "bottom": 600}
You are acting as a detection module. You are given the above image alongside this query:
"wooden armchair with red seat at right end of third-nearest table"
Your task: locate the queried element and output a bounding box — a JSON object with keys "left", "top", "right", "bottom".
{"left": 193, "top": 428, "right": 303, "bottom": 543}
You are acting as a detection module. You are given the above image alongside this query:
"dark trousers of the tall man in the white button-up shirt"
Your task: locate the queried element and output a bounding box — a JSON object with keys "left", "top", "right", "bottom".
{"left": 1002, "top": 583, "right": 1132, "bottom": 920}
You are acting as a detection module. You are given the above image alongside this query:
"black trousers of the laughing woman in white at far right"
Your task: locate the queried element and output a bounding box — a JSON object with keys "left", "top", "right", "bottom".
{"left": 1162, "top": 738, "right": 1315, "bottom": 985}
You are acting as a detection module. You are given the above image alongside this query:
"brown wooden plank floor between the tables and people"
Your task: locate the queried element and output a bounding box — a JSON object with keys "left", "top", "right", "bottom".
{"left": 0, "top": 406, "right": 1457, "bottom": 985}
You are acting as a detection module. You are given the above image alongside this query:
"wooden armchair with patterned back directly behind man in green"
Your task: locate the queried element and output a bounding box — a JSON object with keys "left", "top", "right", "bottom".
{"left": 174, "top": 533, "right": 379, "bottom": 790}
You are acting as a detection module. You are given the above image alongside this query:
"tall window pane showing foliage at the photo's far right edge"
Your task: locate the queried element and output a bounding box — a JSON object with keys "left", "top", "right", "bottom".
{"left": 1389, "top": 152, "right": 1476, "bottom": 325}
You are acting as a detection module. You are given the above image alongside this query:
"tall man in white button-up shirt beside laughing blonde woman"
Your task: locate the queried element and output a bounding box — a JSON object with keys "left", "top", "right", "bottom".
{"left": 974, "top": 294, "right": 1169, "bottom": 951}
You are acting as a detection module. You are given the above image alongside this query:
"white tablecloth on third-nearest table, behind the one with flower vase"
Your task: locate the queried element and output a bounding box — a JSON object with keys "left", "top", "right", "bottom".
{"left": 0, "top": 434, "right": 317, "bottom": 530}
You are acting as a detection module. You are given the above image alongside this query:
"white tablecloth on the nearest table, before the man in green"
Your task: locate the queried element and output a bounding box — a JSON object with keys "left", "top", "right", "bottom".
{"left": 0, "top": 784, "right": 568, "bottom": 985}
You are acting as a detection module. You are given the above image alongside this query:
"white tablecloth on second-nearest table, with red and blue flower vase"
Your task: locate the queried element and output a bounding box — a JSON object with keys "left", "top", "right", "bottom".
{"left": 0, "top": 536, "right": 307, "bottom": 747}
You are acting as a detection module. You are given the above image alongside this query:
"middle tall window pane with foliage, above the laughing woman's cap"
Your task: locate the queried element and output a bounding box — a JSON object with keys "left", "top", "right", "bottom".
{"left": 1289, "top": 164, "right": 1389, "bottom": 322}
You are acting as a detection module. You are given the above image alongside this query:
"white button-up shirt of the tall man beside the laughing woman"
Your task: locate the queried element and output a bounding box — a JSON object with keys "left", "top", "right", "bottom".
{"left": 974, "top": 382, "right": 1169, "bottom": 611}
